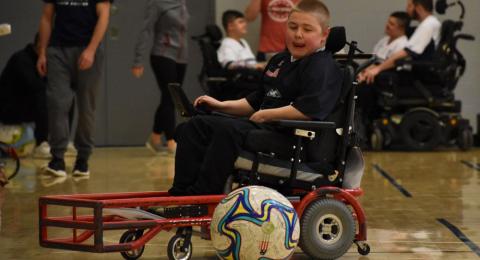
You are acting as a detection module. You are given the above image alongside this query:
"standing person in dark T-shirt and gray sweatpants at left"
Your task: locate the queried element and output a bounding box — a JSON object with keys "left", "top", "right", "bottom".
{"left": 37, "top": 0, "right": 113, "bottom": 177}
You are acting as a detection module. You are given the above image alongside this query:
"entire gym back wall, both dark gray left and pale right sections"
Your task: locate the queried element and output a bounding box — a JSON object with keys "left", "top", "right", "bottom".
{"left": 0, "top": 0, "right": 480, "bottom": 145}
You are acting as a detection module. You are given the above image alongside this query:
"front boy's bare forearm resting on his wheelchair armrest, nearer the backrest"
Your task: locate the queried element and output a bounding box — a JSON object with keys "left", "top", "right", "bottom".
{"left": 250, "top": 105, "right": 312, "bottom": 123}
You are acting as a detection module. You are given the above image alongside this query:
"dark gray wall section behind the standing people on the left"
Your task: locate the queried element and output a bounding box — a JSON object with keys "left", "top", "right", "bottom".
{"left": 0, "top": 0, "right": 215, "bottom": 146}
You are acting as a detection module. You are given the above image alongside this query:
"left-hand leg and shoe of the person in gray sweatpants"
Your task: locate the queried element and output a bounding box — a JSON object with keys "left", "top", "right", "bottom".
{"left": 46, "top": 47, "right": 76, "bottom": 176}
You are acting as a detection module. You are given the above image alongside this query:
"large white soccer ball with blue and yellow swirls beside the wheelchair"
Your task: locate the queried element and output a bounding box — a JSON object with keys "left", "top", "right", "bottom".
{"left": 210, "top": 186, "right": 300, "bottom": 260}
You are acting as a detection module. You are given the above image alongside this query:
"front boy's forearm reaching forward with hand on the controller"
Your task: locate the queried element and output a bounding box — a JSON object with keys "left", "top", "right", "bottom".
{"left": 194, "top": 96, "right": 255, "bottom": 117}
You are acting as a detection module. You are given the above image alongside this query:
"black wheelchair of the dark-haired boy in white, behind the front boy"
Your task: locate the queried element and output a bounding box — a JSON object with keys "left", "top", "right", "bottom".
{"left": 192, "top": 25, "right": 262, "bottom": 101}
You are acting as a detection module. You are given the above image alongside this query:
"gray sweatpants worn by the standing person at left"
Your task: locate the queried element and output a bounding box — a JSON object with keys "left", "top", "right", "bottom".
{"left": 47, "top": 47, "right": 104, "bottom": 160}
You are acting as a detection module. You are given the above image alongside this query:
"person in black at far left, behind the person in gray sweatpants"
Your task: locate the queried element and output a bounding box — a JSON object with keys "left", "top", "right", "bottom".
{"left": 0, "top": 35, "right": 50, "bottom": 157}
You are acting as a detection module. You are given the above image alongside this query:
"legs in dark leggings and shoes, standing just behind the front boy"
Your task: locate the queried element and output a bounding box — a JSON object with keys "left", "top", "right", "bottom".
{"left": 150, "top": 56, "right": 186, "bottom": 150}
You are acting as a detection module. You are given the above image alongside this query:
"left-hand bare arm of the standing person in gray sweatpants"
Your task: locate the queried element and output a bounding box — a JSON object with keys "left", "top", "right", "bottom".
{"left": 37, "top": 3, "right": 55, "bottom": 77}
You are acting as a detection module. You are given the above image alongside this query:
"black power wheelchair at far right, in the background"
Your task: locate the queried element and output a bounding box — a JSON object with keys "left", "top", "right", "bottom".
{"left": 370, "top": 1, "right": 474, "bottom": 150}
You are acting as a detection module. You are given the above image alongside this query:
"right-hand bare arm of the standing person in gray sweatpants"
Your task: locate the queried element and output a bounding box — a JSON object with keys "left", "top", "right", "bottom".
{"left": 78, "top": 0, "right": 110, "bottom": 70}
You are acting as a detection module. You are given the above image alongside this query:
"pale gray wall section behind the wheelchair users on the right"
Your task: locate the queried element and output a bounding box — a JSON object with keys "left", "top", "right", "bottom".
{"left": 215, "top": 0, "right": 480, "bottom": 132}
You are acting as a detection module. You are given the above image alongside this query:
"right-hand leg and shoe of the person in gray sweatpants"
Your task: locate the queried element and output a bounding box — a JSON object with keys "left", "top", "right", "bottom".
{"left": 73, "top": 48, "right": 104, "bottom": 175}
